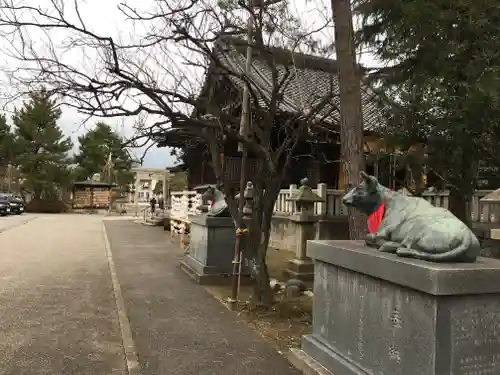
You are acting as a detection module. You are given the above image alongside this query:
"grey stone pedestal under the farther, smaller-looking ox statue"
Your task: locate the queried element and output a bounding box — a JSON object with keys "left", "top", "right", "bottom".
{"left": 181, "top": 215, "right": 250, "bottom": 284}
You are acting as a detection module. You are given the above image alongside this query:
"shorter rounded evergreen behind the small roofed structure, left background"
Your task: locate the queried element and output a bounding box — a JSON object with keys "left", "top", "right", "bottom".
{"left": 75, "top": 122, "right": 133, "bottom": 189}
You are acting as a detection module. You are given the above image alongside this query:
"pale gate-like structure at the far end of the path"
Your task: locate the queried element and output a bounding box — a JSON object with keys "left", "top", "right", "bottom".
{"left": 129, "top": 167, "right": 170, "bottom": 203}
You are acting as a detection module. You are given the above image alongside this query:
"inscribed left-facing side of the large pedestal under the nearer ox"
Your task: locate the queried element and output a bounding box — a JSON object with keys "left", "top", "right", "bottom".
{"left": 313, "top": 268, "right": 436, "bottom": 375}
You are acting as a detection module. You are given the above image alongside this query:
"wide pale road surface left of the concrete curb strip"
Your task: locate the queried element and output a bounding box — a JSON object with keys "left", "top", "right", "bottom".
{"left": 0, "top": 215, "right": 125, "bottom": 375}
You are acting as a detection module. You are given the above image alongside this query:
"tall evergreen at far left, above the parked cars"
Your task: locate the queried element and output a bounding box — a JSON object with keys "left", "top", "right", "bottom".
{"left": 12, "top": 90, "right": 72, "bottom": 199}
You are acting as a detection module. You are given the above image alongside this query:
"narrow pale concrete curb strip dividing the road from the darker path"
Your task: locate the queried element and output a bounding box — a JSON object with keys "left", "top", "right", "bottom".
{"left": 102, "top": 221, "right": 141, "bottom": 375}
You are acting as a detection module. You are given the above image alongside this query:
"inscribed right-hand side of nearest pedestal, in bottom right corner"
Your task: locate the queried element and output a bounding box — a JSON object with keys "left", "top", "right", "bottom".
{"left": 452, "top": 302, "right": 500, "bottom": 375}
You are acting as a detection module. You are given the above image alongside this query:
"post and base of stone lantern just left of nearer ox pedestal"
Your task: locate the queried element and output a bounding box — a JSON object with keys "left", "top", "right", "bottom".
{"left": 283, "top": 213, "right": 317, "bottom": 281}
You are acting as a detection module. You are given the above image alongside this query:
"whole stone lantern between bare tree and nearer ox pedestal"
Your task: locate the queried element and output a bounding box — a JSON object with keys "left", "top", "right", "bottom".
{"left": 284, "top": 178, "right": 325, "bottom": 281}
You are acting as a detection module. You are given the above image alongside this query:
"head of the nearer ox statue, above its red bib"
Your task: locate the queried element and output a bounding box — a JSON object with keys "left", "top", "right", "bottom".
{"left": 342, "top": 172, "right": 383, "bottom": 214}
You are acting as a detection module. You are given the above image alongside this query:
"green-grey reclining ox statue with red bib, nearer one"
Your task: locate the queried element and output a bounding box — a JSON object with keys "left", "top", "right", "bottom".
{"left": 342, "top": 172, "right": 480, "bottom": 263}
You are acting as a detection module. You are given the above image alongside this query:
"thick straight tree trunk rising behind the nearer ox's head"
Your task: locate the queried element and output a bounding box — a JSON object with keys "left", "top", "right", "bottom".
{"left": 331, "top": 0, "right": 366, "bottom": 240}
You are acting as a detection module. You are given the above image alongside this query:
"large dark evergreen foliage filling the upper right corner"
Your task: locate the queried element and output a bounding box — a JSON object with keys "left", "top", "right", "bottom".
{"left": 356, "top": 0, "right": 500, "bottom": 226}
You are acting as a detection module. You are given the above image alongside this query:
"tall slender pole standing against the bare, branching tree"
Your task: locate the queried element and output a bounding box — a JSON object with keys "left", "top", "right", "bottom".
{"left": 229, "top": 0, "right": 254, "bottom": 307}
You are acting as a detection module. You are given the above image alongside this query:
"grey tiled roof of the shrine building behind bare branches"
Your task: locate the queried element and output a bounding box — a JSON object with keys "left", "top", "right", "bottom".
{"left": 215, "top": 37, "right": 384, "bottom": 130}
